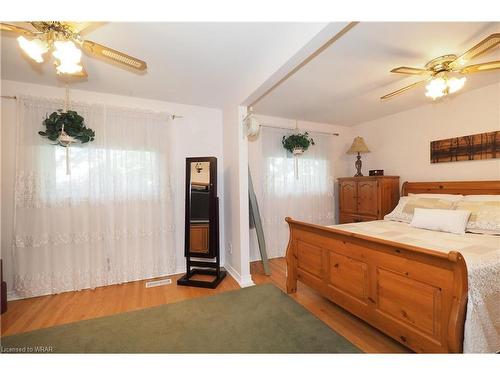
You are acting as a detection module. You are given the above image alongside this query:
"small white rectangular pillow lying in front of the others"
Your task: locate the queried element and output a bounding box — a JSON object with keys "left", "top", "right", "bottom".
{"left": 410, "top": 208, "right": 470, "bottom": 234}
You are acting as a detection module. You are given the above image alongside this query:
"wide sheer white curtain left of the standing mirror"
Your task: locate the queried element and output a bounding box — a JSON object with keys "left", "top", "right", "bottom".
{"left": 13, "top": 97, "right": 175, "bottom": 297}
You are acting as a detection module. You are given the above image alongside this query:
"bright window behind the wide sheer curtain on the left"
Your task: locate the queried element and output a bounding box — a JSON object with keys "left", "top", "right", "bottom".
{"left": 41, "top": 145, "right": 160, "bottom": 203}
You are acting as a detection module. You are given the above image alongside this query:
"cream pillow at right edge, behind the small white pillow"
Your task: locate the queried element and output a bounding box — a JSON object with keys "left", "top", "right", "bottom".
{"left": 455, "top": 201, "right": 500, "bottom": 235}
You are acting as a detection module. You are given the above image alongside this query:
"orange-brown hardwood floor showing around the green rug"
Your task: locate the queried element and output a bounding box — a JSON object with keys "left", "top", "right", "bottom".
{"left": 0, "top": 258, "right": 409, "bottom": 353}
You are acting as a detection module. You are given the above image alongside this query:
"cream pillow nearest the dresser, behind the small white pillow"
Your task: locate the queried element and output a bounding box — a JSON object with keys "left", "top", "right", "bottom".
{"left": 384, "top": 195, "right": 456, "bottom": 223}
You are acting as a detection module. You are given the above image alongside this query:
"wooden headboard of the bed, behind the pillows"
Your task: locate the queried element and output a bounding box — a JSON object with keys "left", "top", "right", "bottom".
{"left": 402, "top": 180, "right": 500, "bottom": 195}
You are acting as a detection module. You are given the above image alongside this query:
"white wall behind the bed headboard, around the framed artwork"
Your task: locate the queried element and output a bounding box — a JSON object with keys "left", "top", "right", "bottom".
{"left": 350, "top": 83, "right": 500, "bottom": 183}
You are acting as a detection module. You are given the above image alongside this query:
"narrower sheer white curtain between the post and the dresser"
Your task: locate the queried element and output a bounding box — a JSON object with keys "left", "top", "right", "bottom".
{"left": 261, "top": 127, "right": 335, "bottom": 258}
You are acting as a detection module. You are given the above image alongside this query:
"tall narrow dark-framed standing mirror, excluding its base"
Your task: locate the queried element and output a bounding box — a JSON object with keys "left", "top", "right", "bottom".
{"left": 185, "top": 158, "right": 218, "bottom": 257}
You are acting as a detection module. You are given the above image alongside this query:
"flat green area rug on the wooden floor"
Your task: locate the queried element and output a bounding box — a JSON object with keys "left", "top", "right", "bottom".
{"left": 1, "top": 284, "right": 360, "bottom": 353}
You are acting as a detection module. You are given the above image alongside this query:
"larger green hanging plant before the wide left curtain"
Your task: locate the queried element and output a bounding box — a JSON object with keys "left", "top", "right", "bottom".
{"left": 38, "top": 109, "right": 95, "bottom": 147}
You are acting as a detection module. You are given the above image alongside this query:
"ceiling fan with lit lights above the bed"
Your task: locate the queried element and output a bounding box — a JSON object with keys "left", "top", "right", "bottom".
{"left": 380, "top": 33, "right": 500, "bottom": 100}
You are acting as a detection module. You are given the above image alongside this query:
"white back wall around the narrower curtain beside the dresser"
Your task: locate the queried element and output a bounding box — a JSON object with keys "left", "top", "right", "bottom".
{"left": 248, "top": 115, "right": 352, "bottom": 261}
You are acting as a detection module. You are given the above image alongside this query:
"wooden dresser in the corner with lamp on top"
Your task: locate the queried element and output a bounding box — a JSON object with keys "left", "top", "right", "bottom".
{"left": 338, "top": 176, "right": 399, "bottom": 224}
